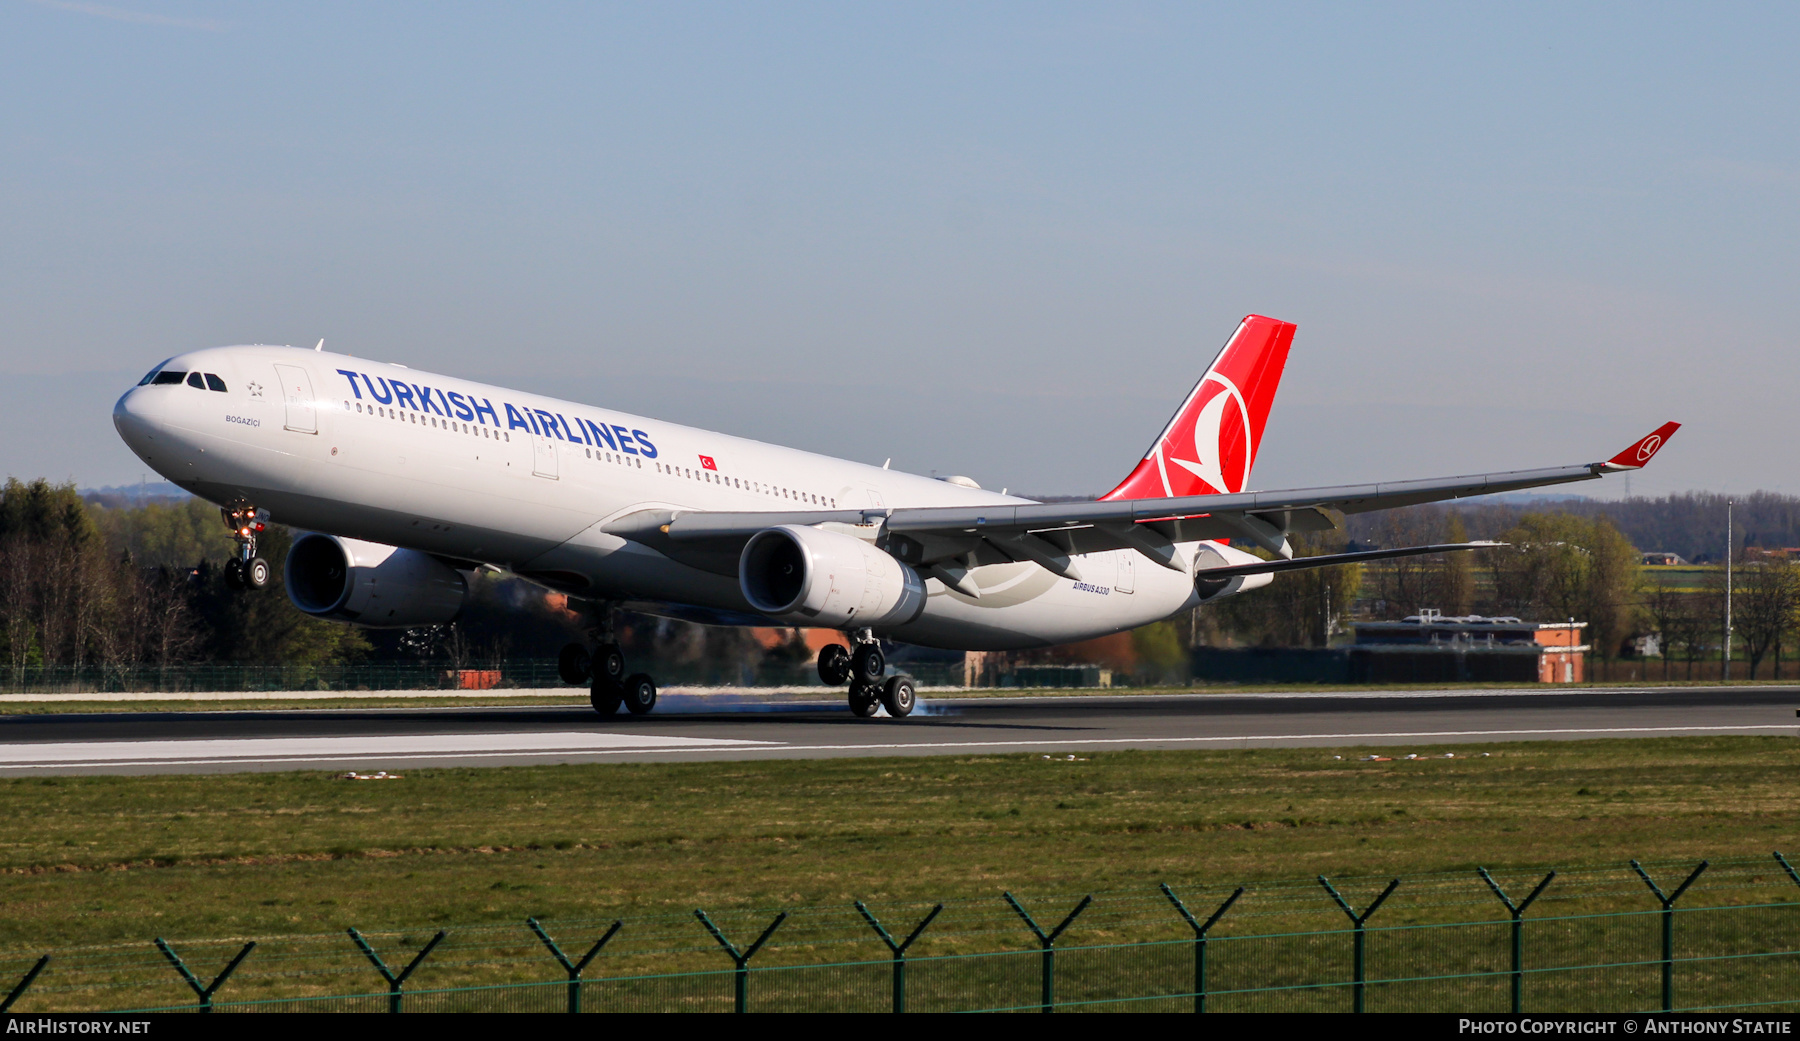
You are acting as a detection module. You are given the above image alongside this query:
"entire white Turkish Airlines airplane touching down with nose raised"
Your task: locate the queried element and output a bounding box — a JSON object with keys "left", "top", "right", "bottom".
{"left": 113, "top": 315, "right": 1679, "bottom": 719}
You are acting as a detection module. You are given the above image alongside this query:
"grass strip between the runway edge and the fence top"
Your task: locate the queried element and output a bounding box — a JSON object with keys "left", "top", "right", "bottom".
{"left": 0, "top": 737, "right": 1800, "bottom": 951}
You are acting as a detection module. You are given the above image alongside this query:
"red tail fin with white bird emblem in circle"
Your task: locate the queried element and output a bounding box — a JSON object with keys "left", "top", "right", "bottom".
{"left": 1102, "top": 315, "right": 1294, "bottom": 499}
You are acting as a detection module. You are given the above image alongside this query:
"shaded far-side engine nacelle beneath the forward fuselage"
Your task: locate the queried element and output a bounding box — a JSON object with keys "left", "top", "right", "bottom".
{"left": 283, "top": 531, "right": 468, "bottom": 629}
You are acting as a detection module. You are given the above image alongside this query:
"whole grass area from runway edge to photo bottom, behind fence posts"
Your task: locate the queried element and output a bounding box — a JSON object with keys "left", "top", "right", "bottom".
{"left": 0, "top": 737, "right": 1800, "bottom": 1009}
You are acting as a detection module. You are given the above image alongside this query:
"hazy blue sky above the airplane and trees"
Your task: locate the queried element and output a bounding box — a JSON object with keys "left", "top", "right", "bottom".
{"left": 0, "top": 0, "right": 1800, "bottom": 493}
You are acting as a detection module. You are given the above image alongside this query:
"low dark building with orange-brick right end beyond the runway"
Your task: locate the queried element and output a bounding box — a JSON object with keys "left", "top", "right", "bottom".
{"left": 1354, "top": 611, "right": 1588, "bottom": 683}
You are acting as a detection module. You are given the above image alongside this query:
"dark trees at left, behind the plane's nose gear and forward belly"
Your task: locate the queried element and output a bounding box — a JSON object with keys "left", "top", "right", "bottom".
{"left": 0, "top": 479, "right": 810, "bottom": 677}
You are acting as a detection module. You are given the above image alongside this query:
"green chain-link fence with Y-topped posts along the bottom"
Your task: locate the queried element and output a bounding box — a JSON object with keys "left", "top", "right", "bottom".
{"left": 0, "top": 854, "right": 1800, "bottom": 1012}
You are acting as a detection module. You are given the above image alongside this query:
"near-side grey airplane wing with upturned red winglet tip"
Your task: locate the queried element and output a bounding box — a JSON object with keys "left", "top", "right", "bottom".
{"left": 605, "top": 423, "right": 1679, "bottom": 584}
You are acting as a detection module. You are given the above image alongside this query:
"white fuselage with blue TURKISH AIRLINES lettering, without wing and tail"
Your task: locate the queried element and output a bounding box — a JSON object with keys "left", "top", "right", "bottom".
{"left": 113, "top": 346, "right": 1251, "bottom": 650}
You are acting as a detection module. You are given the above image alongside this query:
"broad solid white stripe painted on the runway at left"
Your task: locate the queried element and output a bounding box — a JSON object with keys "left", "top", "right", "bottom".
{"left": 0, "top": 731, "right": 778, "bottom": 769}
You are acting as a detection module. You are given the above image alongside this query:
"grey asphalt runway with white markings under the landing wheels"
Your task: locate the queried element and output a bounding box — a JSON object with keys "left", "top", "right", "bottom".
{"left": 0, "top": 686, "right": 1800, "bottom": 776}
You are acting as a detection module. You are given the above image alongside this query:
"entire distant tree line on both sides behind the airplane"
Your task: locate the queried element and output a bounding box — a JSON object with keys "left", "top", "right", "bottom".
{"left": 0, "top": 481, "right": 1800, "bottom": 675}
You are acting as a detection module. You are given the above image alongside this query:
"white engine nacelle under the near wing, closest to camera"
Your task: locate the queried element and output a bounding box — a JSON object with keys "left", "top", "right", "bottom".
{"left": 738, "top": 524, "right": 925, "bottom": 629}
